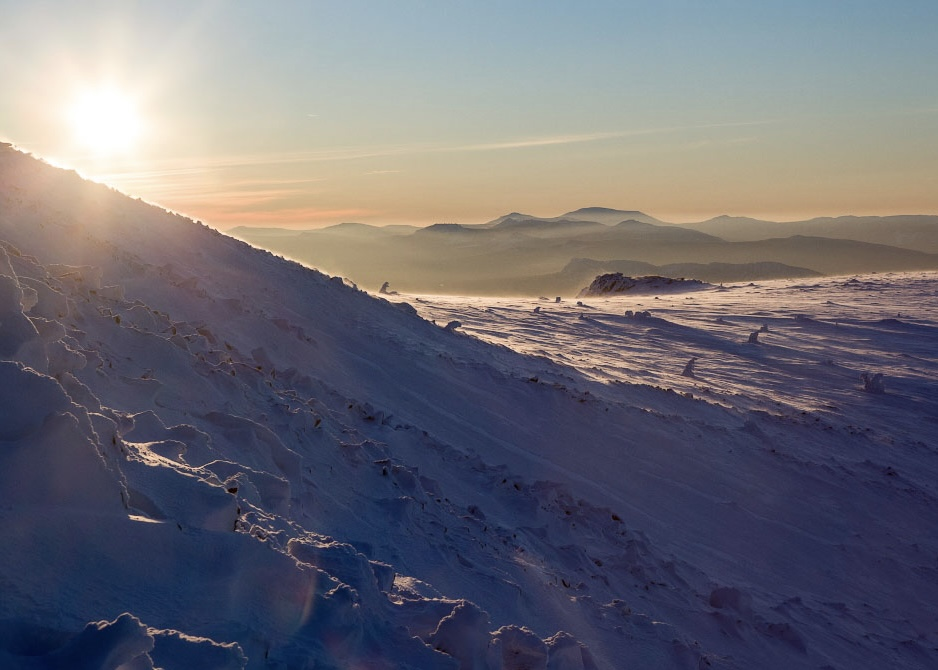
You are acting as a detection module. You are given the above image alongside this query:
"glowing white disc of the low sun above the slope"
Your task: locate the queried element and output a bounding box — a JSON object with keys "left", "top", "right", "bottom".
{"left": 67, "top": 88, "right": 142, "bottom": 157}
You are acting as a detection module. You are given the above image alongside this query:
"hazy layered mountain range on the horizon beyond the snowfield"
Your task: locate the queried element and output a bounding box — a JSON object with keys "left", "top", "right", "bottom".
{"left": 232, "top": 207, "right": 938, "bottom": 295}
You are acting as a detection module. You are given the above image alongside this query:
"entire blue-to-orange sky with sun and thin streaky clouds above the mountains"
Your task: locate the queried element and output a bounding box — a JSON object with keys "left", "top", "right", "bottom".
{"left": 0, "top": 0, "right": 938, "bottom": 229}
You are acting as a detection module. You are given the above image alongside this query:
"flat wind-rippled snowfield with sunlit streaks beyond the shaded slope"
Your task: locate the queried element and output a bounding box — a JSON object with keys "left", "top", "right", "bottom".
{"left": 391, "top": 273, "right": 938, "bottom": 439}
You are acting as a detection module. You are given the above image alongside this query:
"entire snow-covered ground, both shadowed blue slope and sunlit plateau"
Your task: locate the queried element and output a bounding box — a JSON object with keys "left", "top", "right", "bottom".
{"left": 0, "top": 145, "right": 938, "bottom": 670}
